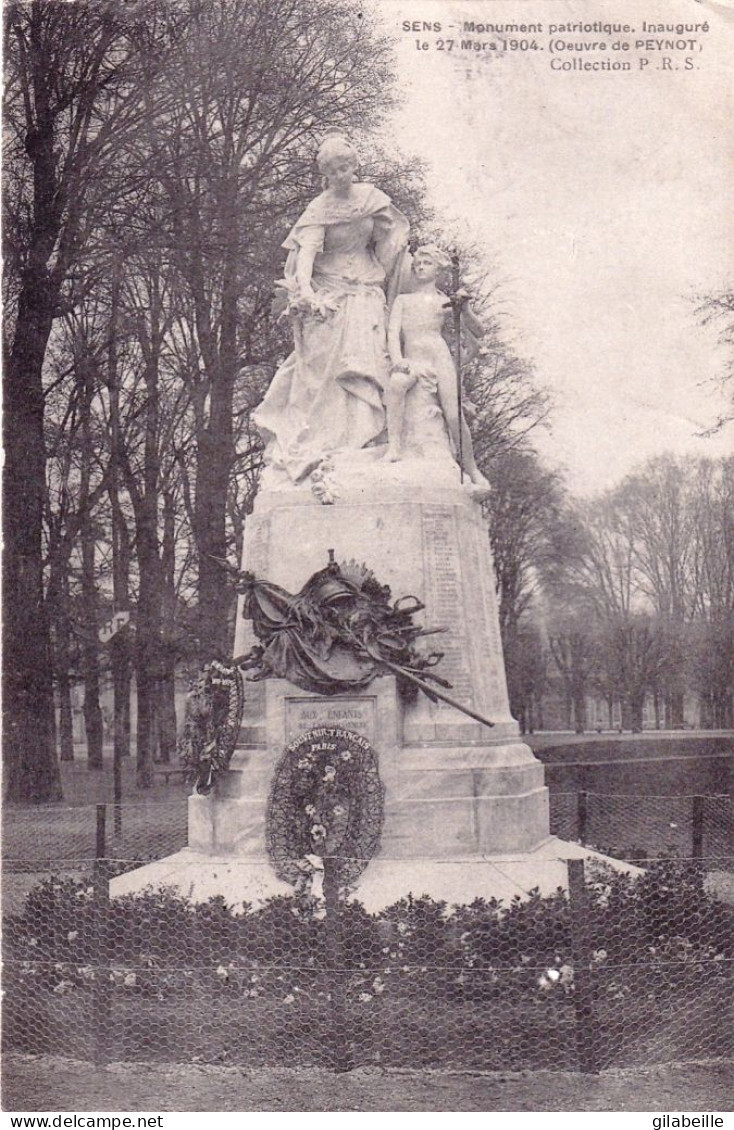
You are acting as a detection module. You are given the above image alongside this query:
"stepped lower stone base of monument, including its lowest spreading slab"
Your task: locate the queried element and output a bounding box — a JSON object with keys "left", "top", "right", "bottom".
{"left": 113, "top": 676, "right": 560, "bottom": 909}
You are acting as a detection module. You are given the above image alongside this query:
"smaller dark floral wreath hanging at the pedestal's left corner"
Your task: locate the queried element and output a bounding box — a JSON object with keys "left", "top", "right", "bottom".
{"left": 178, "top": 660, "right": 245, "bottom": 793}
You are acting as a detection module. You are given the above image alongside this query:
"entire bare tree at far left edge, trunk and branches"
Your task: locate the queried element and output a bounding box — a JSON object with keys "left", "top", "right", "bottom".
{"left": 3, "top": 0, "right": 181, "bottom": 800}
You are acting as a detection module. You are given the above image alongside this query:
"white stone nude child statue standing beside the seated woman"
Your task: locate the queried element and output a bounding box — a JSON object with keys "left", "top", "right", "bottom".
{"left": 385, "top": 244, "right": 489, "bottom": 489}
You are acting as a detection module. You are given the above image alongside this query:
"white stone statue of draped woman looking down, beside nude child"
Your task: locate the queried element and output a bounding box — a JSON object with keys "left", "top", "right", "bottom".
{"left": 254, "top": 134, "right": 408, "bottom": 483}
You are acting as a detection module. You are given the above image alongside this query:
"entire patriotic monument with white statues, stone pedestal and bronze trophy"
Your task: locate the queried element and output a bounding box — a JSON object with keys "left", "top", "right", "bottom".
{"left": 113, "top": 129, "right": 623, "bottom": 910}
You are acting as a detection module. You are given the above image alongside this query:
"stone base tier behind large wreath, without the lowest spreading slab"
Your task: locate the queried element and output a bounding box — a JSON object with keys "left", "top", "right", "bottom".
{"left": 182, "top": 676, "right": 549, "bottom": 867}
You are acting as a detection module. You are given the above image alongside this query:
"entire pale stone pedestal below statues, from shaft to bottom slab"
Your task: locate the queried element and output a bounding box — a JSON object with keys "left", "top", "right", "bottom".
{"left": 115, "top": 449, "right": 636, "bottom": 910}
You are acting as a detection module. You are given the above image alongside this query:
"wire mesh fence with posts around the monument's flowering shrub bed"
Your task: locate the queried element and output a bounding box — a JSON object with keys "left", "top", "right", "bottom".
{"left": 3, "top": 794, "right": 734, "bottom": 1071}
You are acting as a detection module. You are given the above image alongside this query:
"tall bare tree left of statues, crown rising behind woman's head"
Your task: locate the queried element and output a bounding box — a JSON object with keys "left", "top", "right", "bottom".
{"left": 138, "top": 0, "right": 390, "bottom": 653}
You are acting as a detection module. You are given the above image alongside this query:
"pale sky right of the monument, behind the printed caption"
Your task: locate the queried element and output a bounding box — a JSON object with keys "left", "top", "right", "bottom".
{"left": 376, "top": 0, "right": 734, "bottom": 494}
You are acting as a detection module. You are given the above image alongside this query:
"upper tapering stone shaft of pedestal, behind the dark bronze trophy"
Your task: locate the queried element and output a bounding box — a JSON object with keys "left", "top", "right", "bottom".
{"left": 235, "top": 449, "right": 517, "bottom": 756}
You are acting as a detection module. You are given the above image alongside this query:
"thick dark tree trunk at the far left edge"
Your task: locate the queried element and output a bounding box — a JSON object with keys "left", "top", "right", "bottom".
{"left": 3, "top": 5, "right": 64, "bottom": 801}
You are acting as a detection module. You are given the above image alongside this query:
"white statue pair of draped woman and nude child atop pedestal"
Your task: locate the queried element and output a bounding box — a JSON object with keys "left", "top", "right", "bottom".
{"left": 254, "top": 134, "right": 488, "bottom": 493}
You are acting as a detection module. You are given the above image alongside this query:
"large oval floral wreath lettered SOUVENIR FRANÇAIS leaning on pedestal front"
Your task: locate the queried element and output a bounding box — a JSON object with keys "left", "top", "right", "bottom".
{"left": 266, "top": 728, "right": 384, "bottom": 888}
